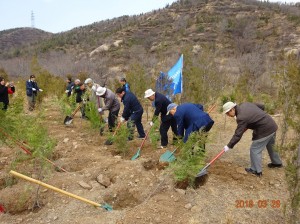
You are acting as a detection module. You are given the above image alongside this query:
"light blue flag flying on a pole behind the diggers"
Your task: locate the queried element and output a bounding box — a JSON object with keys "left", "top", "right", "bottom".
{"left": 168, "top": 55, "right": 183, "bottom": 95}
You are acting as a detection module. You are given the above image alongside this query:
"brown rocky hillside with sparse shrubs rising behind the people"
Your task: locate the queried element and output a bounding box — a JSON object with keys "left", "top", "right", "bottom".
{"left": 0, "top": 0, "right": 300, "bottom": 80}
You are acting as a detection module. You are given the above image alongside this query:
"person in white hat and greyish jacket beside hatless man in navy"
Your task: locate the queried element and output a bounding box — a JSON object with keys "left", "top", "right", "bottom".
{"left": 96, "top": 86, "right": 120, "bottom": 132}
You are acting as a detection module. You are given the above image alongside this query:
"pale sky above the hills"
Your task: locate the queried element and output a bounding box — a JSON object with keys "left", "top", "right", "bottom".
{"left": 0, "top": 0, "right": 300, "bottom": 33}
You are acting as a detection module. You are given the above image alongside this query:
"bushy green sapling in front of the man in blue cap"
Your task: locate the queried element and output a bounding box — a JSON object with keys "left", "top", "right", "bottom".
{"left": 169, "top": 132, "right": 207, "bottom": 186}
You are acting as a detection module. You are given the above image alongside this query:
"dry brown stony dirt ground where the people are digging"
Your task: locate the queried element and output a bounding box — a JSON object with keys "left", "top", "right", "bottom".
{"left": 0, "top": 99, "right": 290, "bottom": 224}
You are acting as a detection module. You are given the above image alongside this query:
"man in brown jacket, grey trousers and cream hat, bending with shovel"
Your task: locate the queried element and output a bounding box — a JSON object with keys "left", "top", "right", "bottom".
{"left": 223, "top": 102, "right": 282, "bottom": 177}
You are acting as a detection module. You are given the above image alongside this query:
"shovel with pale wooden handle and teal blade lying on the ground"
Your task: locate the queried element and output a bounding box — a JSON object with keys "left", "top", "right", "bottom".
{"left": 9, "top": 170, "right": 112, "bottom": 211}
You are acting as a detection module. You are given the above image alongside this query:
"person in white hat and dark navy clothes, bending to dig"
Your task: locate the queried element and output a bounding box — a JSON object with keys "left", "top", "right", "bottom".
{"left": 144, "top": 89, "right": 177, "bottom": 149}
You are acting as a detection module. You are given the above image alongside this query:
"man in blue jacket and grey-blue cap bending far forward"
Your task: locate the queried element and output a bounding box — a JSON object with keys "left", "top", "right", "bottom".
{"left": 167, "top": 103, "right": 214, "bottom": 142}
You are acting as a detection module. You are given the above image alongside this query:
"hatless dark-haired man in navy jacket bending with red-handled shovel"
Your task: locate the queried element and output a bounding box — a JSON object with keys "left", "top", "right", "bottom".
{"left": 116, "top": 87, "right": 146, "bottom": 140}
